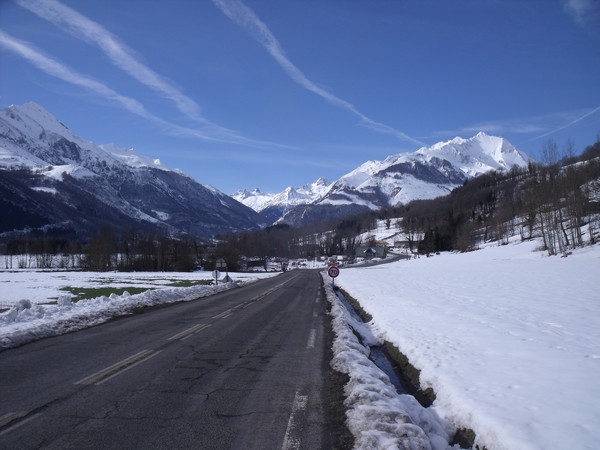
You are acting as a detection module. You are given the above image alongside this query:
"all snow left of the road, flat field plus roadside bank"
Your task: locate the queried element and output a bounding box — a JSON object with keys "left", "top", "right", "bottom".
{"left": 0, "top": 270, "right": 275, "bottom": 349}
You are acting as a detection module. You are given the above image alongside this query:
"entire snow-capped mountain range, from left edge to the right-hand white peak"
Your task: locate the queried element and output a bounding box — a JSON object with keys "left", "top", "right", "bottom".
{"left": 0, "top": 103, "right": 529, "bottom": 240}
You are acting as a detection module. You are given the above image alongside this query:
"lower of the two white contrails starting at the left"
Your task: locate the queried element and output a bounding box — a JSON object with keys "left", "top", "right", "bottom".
{"left": 0, "top": 29, "right": 290, "bottom": 148}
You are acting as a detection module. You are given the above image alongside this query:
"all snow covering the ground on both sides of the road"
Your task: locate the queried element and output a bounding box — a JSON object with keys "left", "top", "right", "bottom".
{"left": 0, "top": 241, "right": 600, "bottom": 450}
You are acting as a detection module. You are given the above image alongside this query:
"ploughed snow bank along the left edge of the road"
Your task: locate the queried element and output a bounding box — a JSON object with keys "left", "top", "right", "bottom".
{"left": 0, "top": 275, "right": 276, "bottom": 350}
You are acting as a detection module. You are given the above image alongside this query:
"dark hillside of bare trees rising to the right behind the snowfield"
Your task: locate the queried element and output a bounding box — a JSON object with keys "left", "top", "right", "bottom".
{"left": 219, "top": 142, "right": 600, "bottom": 259}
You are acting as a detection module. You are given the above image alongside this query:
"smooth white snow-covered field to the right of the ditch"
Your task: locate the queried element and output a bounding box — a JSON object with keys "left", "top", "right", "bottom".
{"left": 336, "top": 242, "right": 600, "bottom": 450}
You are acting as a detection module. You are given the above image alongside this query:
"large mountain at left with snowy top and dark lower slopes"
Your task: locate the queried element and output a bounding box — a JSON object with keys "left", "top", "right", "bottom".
{"left": 0, "top": 103, "right": 263, "bottom": 238}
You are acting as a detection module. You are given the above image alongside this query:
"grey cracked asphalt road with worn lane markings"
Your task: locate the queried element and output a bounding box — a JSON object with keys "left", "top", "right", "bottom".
{"left": 0, "top": 271, "right": 332, "bottom": 449}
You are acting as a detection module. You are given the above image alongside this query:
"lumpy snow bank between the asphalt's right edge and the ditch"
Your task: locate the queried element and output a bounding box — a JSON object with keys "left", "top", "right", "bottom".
{"left": 323, "top": 273, "right": 458, "bottom": 450}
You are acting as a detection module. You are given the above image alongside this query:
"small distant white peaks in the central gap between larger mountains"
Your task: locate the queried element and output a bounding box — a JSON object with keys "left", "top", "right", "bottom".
{"left": 233, "top": 178, "right": 332, "bottom": 223}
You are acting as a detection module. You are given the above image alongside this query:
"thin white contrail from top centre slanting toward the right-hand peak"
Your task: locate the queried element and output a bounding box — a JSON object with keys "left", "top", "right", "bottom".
{"left": 213, "top": 0, "right": 425, "bottom": 145}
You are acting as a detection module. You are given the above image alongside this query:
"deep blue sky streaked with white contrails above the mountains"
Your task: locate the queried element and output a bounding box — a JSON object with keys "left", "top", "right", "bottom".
{"left": 0, "top": 0, "right": 600, "bottom": 194}
